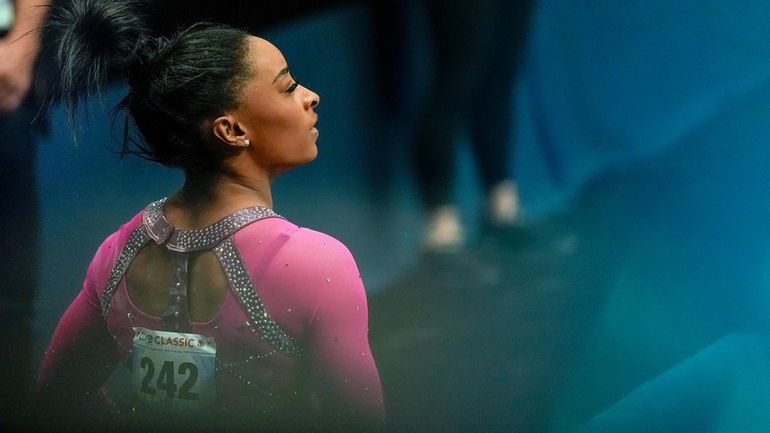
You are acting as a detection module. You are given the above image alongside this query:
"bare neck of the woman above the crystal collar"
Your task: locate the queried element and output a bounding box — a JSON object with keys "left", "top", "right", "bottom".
{"left": 165, "top": 174, "right": 273, "bottom": 229}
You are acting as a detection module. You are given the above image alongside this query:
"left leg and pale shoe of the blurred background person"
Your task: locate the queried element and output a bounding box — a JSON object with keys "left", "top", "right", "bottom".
{"left": 415, "top": 0, "right": 493, "bottom": 249}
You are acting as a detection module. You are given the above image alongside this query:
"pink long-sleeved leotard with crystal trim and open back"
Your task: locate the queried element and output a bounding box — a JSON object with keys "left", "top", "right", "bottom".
{"left": 38, "top": 200, "right": 384, "bottom": 426}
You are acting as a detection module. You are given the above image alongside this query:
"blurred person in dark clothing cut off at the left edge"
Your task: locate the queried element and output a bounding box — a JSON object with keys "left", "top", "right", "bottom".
{"left": 0, "top": 0, "right": 48, "bottom": 426}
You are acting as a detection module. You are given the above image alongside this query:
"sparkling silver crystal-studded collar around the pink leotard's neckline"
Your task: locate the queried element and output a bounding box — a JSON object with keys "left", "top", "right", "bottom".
{"left": 142, "top": 198, "right": 283, "bottom": 252}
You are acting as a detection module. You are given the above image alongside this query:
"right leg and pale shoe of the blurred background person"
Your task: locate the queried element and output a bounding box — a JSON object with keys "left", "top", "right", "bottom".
{"left": 471, "top": 0, "right": 532, "bottom": 226}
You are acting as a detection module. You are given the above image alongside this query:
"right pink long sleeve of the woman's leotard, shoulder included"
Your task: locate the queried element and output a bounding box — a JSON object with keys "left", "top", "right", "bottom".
{"left": 239, "top": 221, "right": 385, "bottom": 431}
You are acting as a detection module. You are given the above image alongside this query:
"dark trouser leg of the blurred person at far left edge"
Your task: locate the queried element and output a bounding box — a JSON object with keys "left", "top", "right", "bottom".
{"left": 0, "top": 97, "right": 40, "bottom": 425}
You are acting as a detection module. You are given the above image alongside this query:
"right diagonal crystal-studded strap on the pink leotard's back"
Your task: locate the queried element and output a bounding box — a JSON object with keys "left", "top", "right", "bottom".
{"left": 214, "top": 238, "right": 302, "bottom": 356}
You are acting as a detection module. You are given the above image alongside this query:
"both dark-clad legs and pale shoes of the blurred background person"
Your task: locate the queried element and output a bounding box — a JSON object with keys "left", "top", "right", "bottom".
{"left": 414, "top": 0, "right": 532, "bottom": 251}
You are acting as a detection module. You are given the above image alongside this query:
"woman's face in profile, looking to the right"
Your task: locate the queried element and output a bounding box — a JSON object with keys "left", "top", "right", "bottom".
{"left": 236, "top": 36, "right": 320, "bottom": 175}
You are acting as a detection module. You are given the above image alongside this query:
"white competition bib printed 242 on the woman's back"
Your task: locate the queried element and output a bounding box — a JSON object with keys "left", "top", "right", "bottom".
{"left": 131, "top": 327, "right": 217, "bottom": 410}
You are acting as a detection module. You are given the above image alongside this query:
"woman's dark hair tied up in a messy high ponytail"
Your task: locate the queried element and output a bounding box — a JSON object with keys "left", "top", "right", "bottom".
{"left": 48, "top": 0, "right": 251, "bottom": 173}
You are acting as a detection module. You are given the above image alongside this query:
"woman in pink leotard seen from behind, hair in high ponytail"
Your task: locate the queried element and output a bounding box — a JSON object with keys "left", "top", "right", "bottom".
{"left": 38, "top": 0, "right": 384, "bottom": 431}
